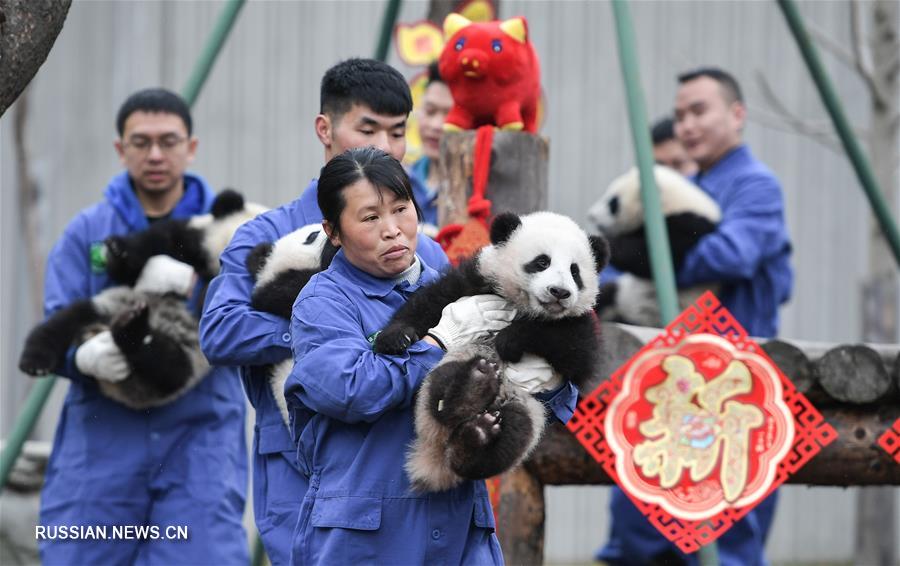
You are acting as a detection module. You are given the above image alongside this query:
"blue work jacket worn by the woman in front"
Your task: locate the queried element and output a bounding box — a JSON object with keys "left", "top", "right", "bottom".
{"left": 285, "top": 252, "right": 503, "bottom": 565}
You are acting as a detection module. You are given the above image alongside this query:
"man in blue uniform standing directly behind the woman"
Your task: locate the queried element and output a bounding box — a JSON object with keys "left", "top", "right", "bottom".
{"left": 200, "top": 59, "right": 448, "bottom": 565}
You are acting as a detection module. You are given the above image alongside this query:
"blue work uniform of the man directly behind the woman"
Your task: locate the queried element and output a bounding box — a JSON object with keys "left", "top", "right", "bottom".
{"left": 200, "top": 179, "right": 449, "bottom": 565}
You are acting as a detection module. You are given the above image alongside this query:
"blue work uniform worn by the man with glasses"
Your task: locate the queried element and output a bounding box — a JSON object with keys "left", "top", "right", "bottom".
{"left": 41, "top": 172, "right": 248, "bottom": 562}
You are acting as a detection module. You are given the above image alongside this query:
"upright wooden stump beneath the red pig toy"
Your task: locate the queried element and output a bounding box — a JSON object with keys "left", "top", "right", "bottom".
{"left": 438, "top": 130, "right": 550, "bottom": 226}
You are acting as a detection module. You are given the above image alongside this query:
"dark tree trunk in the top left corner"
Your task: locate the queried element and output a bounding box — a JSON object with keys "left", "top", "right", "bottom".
{"left": 0, "top": 0, "right": 72, "bottom": 116}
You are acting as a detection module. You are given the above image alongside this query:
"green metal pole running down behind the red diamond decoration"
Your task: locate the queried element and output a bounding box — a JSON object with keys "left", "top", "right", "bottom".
{"left": 612, "top": 0, "right": 719, "bottom": 566}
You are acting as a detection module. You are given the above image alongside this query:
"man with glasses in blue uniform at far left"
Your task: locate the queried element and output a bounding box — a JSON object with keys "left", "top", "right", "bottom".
{"left": 40, "top": 89, "right": 248, "bottom": 565}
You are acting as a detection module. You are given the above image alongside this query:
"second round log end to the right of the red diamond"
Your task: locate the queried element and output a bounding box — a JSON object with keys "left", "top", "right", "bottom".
{"left": 814, "top": 344, "right": 894, "bottom": 404}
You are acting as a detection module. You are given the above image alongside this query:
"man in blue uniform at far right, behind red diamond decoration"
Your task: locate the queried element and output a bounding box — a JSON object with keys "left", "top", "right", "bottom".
{"left": 597, "top": 68, "right": 793, "bottom": 566}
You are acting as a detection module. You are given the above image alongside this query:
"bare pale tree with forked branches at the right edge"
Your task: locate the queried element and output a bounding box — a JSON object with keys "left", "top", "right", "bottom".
{"left": 756, "top": 0, "right": 900, "bottom": 565}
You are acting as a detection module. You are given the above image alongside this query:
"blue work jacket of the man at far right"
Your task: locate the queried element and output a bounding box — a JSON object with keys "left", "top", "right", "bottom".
{"left": 677, "top": 145, "right": 794, "bottom": 337}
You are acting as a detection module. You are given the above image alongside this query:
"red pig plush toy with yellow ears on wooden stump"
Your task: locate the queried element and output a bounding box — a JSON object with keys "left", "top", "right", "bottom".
{"left": 438, "top": 14, "right": 541, "bottom": 133}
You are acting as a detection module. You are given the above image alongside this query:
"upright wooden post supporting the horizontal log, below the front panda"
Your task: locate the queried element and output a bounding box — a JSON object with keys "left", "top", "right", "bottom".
{"left": 497, "top": 468, "right": 544, "bottom": 565}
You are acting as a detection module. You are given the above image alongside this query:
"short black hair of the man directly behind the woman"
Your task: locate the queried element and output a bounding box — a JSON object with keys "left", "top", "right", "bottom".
{"left": 319, "top": 59, "right": 412, "bottom": 119}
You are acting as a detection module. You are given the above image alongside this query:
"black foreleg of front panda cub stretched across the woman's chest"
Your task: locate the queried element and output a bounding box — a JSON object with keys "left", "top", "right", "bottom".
{"left": 375, "top": 260, "right": 495, "bottom": 354}
